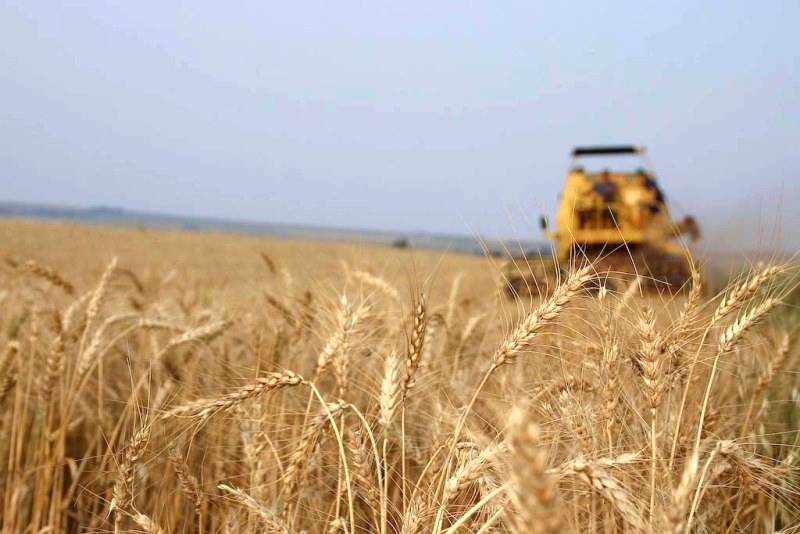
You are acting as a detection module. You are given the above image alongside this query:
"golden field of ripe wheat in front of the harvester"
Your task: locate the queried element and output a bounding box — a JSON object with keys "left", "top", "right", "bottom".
{"left": 0, "top": 220, "right": 800, "bottom": 534}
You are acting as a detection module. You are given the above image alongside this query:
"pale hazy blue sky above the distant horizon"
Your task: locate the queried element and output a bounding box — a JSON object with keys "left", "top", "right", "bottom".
{"left": 0, "top": 0, "right": 800, "bottom": 247}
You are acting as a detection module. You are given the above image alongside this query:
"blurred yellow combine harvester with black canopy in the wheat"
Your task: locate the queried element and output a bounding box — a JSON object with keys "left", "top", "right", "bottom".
{"left": 504, "top": 146, "right": 700, "bottom": 296}
